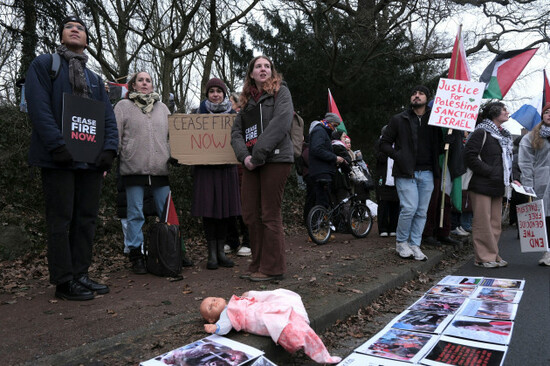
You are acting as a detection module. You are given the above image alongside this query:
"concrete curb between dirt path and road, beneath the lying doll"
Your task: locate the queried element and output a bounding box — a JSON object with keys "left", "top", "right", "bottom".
{"left": 29, "top": 249, "right": 448, "bottom": 366}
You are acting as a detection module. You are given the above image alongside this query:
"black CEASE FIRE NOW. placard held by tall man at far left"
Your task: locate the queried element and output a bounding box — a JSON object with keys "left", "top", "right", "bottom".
{"left": 61, "top": 93, "right": 105, "bottom": 163}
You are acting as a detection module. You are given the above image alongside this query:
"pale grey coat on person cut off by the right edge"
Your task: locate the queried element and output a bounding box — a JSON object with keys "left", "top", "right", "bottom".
{"left": 518, "top": 132, "right": 550, "bottom": 212}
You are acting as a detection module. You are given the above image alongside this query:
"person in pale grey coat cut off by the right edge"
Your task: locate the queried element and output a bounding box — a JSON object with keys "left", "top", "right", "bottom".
{"left": 514, "top": 103, "right": 550, "bottom": 266}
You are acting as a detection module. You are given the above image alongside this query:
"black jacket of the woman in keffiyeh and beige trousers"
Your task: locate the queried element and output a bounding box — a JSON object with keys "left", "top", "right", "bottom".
{"left": 464, "top": 129, "right": 504, "bottom": 197}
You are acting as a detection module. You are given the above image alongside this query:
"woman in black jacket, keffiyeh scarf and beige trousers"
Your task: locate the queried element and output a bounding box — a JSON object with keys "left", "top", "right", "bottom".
{"left": 464, "top": 102, "right": 513, "bottom": 268}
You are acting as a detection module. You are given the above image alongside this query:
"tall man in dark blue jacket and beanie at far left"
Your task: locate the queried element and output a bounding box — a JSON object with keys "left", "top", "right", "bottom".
{"left": 25, "top": 16, "right": 118, "bottom": 300}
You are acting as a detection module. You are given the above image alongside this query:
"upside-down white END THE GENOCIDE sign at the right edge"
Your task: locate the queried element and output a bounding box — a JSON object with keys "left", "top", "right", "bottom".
{"left": 516, "top": 200, "right": 548, "bottom": 252}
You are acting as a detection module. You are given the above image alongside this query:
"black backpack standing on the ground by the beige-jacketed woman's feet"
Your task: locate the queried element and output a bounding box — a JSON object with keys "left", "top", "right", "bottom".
{"left": 145, "top": 222, "right": 183, "bottom": 277}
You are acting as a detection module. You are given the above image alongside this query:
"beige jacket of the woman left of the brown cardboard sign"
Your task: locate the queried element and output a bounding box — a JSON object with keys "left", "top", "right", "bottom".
{"left": 115, "top": 99, "right": 170, "bottom": 176}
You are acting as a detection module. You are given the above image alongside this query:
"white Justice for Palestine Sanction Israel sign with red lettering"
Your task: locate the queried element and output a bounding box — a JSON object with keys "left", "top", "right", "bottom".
{"left": 428, "top": 78, "right": 485, "bottom": 131}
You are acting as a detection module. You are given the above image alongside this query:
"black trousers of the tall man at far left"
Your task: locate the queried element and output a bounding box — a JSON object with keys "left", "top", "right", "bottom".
{"left": 41, "top": 168, "right": 103, "bottom": 285}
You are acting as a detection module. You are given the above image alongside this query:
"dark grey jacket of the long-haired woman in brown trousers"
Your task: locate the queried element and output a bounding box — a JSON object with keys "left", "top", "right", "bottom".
{"left": 231, "top": 85, "right": 294, "bottom": 165}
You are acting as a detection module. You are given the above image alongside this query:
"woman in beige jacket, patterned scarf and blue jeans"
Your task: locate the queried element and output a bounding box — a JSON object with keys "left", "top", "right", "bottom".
{"left": 115, "top": 71, "right": 175, "bottom": 274}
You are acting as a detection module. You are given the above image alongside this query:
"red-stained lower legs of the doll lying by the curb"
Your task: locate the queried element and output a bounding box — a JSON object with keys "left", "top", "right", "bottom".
{"left": 277, "top": 311, "right": 342, "bottom": 363}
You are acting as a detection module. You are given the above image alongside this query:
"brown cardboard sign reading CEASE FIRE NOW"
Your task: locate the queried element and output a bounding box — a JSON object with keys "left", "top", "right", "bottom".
{"left": 168, "top": 113, "right": 239, "bottom": 165}
